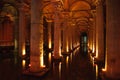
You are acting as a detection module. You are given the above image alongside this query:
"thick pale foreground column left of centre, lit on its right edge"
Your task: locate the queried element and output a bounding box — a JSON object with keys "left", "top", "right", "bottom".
{"left": 30, "top": 0, "right": 44, "bottom": 72}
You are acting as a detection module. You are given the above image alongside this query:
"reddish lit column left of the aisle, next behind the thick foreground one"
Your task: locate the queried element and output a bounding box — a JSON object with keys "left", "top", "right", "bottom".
{"left": 53, "top": 1, "right": 61, "bottom": 59}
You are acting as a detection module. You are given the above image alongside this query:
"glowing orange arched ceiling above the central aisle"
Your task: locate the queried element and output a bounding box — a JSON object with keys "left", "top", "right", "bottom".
{"left": 43, "top": 0, "right": 95, "bottom": 31}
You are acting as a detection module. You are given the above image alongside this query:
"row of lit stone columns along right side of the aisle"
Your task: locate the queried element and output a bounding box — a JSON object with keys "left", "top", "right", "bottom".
{"left": 89, "top": 0, "right": 120, "bottom": 79}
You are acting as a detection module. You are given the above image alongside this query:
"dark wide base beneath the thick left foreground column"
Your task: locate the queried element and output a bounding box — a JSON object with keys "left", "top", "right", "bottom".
{"left": 22, "top": 68, "right": 49, "bottom": 77}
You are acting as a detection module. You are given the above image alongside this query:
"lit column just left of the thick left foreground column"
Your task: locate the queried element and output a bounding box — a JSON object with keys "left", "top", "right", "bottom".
{"left": 19, "top": 3, "right": 26, "bottom": 57}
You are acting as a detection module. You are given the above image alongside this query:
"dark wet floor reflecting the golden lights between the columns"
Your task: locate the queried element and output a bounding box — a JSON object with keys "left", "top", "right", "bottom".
{"left": 0, "top": 50, "right": 100, "bottom": 80}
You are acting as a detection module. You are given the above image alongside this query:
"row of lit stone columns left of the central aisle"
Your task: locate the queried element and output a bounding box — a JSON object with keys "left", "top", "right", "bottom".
{"left": 15, "top": 0, "right": 79, "bottom": 72}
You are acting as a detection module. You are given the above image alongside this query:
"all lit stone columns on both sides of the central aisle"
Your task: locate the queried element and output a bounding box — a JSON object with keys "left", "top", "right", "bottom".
{"left": 16, "top": 0, "right": 120, "bottom": 78}
